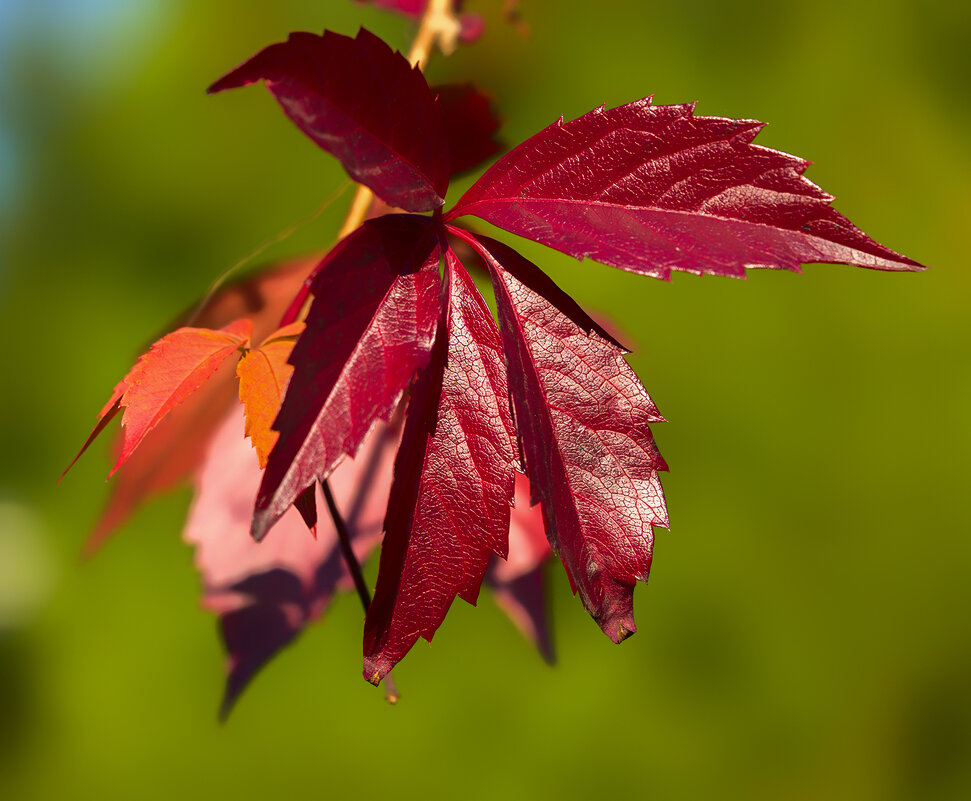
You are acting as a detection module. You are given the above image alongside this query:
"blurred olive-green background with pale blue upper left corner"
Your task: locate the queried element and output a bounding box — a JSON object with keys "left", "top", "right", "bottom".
{"left": 0, "top": 0, "right": 971, "bottom": 801}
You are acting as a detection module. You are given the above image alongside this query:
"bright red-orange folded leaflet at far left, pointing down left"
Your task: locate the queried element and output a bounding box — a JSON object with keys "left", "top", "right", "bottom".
{"left": 62, "top": 320, "right": 253, "bottom": 478}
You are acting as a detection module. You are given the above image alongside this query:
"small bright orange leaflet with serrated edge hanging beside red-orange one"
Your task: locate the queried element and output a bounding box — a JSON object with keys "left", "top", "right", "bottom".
{"left": 236, "top": 322, "right": 304, "bottom": 469}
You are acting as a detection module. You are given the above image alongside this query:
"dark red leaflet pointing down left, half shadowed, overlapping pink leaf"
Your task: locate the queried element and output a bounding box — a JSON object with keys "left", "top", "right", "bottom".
{"left": 253, "top": 219, "right": 440, "bottom": 539}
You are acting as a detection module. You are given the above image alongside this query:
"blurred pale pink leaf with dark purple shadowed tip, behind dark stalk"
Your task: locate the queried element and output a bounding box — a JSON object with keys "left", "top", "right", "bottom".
{"left": 184, "top": 405, "right": 398, "bottom": 715}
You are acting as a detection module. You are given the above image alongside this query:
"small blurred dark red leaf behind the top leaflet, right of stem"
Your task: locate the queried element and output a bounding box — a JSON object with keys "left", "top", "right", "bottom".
{"left": 432, "top": 83, "right": 502, "bottom": 175}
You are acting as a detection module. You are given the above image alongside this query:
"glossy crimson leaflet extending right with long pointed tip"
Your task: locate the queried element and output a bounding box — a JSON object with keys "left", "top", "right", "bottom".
{"left": 446, "top": 98, "right": 923, "bottom": 279}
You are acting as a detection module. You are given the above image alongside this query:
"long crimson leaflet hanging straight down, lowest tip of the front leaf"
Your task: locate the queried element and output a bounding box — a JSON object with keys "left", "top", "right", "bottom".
{"left": 364, "top": 245, "right": 515, "bottom": 684}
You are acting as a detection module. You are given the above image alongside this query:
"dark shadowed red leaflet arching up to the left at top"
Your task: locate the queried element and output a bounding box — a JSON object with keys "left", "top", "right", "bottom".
{"left": 209, "top": 28, "right": 449, "bottom": 211}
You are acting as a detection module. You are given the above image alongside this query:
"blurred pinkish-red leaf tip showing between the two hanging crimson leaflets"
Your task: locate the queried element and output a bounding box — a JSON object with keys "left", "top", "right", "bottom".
{"left": 486, "top": 473, "right": 555, "bottom": 664}
